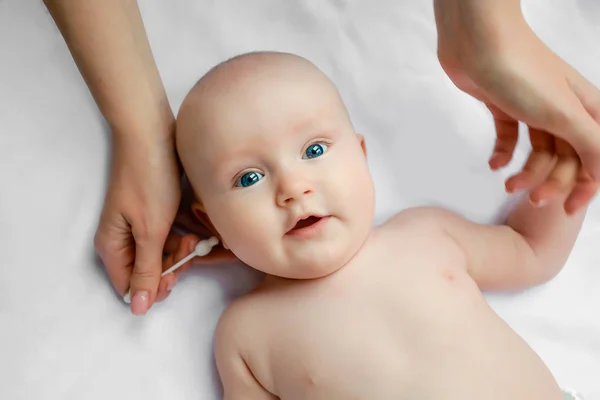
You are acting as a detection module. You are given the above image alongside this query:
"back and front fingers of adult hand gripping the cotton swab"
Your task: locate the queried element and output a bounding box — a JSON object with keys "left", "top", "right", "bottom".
{"left": 95, "top": 135, "right": 181, "bottom": 315}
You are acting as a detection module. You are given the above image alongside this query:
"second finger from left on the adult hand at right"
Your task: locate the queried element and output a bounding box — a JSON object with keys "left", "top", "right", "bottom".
{"left": 505, "top": 128, "right": 555, "bottom": 193}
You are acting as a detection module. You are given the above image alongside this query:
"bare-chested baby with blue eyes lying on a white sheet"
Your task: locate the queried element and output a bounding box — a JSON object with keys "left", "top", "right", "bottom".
{"left": 176, "top": 52, "right": 585, "bottom": 400}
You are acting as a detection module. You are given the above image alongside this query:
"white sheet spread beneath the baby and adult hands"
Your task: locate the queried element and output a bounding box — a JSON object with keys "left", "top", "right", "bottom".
{"left": 0, "top": 0, "right": 600, "bottom": 400}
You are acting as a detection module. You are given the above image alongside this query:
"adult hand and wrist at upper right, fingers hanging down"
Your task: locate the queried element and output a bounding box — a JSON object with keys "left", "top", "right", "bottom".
{"left": 434, "top": 0, "right": 600, "bottom": 213}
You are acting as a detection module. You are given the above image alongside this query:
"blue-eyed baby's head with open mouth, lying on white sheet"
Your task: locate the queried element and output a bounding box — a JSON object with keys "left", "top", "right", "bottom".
{"left": 176, "top": 53, "right": 375, "bottom": 279}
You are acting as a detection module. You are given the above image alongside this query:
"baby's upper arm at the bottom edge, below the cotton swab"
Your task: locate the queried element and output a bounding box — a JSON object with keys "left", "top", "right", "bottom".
{"left": 214, "top": 307, "right": 278, "bottom": 400}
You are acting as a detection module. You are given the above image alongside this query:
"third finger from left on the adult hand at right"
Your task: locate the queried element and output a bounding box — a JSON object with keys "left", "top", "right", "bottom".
{"left": 529, "top": 138, "right": 581, "bottom": 207}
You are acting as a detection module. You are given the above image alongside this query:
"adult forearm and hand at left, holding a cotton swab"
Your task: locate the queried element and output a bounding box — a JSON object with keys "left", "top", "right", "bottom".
{"left": 44, "top": 0, "right": 237, "bottom": 314}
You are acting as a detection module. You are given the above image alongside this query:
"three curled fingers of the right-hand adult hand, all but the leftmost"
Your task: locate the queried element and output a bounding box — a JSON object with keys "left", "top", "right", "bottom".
{"left": 498, "top": 128, "right": 598, "bottom": 214}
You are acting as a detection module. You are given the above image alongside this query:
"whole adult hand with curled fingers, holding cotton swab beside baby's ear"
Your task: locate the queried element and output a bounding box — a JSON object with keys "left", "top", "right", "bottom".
{"left": 95, "top": 143, "right": 236, "bottom": 315}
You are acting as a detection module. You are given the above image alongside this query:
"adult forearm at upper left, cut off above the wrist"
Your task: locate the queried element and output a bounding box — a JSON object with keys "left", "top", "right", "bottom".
{"left": 44, "top": 0, "right": 174, "bottom": 135}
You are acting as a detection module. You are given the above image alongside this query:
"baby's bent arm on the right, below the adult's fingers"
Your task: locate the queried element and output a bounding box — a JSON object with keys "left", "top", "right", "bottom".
{"left": 437, "top": 191, "right": 585, "bottom": 290}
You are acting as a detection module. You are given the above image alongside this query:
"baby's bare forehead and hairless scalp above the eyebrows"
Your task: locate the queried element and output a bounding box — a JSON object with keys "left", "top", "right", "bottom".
{"left": 178, "top": 52, "right": 347, "bottom": 170}
